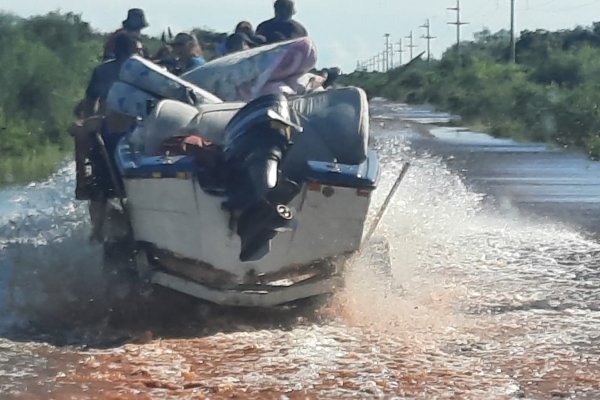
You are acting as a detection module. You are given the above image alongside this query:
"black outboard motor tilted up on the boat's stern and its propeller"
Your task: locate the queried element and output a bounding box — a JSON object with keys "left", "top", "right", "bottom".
{"left": 223, "top": 95, "right": 302, "bottom": 261}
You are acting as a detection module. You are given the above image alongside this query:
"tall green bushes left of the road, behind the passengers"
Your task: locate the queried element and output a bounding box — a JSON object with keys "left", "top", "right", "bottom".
{"left": 0, "top": 12, "right": 225, "bottom": 185}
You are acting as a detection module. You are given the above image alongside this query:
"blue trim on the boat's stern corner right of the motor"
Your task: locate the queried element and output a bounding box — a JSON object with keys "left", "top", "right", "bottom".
{"left": 306, "top": 150, "right": 379, "bottom": 189}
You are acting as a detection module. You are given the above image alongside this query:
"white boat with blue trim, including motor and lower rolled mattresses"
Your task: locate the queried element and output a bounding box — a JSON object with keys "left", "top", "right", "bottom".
{"left": 98, "top": 38, "right": 390, "bottom": 307}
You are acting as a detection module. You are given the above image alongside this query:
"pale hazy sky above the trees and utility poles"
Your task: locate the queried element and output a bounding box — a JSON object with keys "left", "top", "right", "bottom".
{"left": 0, "top": 0, "right": 600, "bottom": 72}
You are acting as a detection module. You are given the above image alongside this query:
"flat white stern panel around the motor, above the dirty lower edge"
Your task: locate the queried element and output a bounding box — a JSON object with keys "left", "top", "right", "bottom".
{"left": 125, "top": 165, "right": 370, "bottom": 283}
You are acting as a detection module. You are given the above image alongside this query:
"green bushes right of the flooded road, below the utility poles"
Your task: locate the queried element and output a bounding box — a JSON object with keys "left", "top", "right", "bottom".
{"left": 343, "top": 23, "right": 600, "bottom": 159}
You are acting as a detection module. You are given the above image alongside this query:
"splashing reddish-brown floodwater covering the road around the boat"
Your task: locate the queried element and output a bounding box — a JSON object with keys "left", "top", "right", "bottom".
{"left": 0, "top": 101, "right": 600, "bottom": 399}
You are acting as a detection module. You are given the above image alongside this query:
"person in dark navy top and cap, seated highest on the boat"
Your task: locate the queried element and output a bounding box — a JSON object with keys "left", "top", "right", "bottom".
{"left": 256, "top": 0, "right": 308, "bottom": 43}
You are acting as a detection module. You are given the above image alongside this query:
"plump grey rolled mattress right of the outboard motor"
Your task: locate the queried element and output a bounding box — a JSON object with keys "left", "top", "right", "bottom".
{"left": 283, "top": 87, "right": 369, "bottom": 176}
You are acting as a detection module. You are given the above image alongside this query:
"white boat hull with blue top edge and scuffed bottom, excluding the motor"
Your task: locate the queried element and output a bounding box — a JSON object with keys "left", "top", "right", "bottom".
{"left": 115, "top": 153, "right": 378, "bottom": 307}
